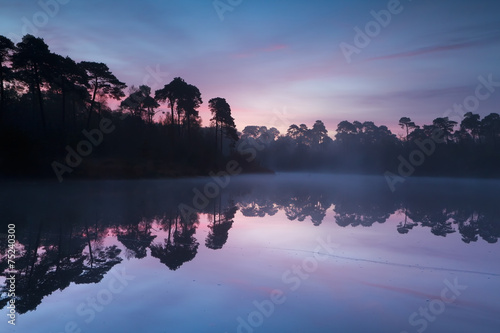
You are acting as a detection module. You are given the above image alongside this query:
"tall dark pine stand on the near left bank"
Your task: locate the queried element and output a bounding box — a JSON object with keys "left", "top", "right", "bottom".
{"left": 0, "top": 35, "right": 244, "bottom": 180}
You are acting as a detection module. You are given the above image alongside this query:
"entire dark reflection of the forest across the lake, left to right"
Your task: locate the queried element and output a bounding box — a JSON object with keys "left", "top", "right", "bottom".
{"left": 0, "top": 176, "right": 500, "bottom": 313}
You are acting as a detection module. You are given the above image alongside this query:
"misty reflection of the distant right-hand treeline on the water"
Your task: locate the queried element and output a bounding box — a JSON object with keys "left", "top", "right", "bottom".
{"left": 237, "top": 176, "right": 500, "bottom": 243}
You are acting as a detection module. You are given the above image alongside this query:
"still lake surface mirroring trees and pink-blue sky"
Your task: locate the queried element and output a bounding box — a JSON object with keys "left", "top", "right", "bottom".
{"left": 0, "top": 174, "right": 500, "bottom": 333}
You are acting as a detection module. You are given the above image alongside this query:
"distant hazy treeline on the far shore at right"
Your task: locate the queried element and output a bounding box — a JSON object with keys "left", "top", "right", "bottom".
{"left": 249, "top": 112, "right": 500, "bottom": 178}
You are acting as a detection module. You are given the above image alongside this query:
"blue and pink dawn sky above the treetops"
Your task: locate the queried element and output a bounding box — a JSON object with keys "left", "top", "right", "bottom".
{"left": 0, "top": 0, "right": 500, "bottom": 133}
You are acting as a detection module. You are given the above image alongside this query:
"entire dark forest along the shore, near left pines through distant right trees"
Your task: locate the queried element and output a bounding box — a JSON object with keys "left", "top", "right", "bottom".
{"left": 0, "top": 35, "right": 500, "bottom": 179}
